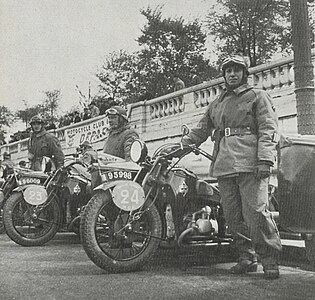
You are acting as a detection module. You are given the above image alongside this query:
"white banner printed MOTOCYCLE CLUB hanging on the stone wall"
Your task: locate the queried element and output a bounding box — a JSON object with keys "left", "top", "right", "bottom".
{"left": 65, "top": 117, "right": 109, "bottom": 147}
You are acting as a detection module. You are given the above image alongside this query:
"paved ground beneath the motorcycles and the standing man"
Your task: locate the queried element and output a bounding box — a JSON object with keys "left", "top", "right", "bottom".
{"left": 0, "top": 234, "right": 315, "bottom": 300}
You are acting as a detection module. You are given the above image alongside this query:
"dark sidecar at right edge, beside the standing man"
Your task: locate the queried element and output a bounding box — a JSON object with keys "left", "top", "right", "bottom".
{"left": 278, "top": 135, "right": 315, "bottom": 264}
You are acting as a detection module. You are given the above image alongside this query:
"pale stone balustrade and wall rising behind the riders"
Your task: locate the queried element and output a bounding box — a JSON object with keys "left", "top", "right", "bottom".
{"left": 0, "top": 49, "right": 315, "bottom": 178}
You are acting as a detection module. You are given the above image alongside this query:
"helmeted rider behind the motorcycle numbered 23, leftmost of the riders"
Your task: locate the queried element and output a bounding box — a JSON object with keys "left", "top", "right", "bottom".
{"left": 28, "top": 116, "right": 64, "bottom": 171}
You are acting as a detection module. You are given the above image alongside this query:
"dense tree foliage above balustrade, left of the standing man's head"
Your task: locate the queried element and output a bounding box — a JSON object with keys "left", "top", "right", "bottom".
{"left": 93, "top": 7, "right": 216, "bottom": 107}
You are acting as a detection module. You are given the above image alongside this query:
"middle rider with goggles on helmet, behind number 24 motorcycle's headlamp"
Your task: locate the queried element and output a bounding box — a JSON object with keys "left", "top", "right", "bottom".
{"left": 103, "top": 106, "right": 139, "bottom": 160}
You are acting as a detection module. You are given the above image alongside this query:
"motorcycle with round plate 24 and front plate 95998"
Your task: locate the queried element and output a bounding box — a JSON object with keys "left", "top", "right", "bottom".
{"left": 81, "top": 127, "right": 232, "bottom": 273}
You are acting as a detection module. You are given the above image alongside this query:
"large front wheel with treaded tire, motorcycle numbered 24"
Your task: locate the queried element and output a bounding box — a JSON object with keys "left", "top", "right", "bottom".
{"left": 80, "top": 192, "right": 162, "bottom": 273}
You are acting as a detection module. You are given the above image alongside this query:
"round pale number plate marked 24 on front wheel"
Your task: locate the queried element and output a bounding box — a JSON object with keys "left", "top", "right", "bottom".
{"left": 112, "top": 181, "right": 145, "bottom": 211}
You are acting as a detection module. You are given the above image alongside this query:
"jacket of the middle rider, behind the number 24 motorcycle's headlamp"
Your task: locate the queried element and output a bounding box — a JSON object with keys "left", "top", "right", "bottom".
{"left": 103, "top": 126, "right": 139, "bottom": 160}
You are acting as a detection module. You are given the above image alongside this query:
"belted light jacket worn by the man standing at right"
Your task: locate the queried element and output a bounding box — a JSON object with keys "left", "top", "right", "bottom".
{"left": 183, "top": 84, "right": 278, "bottom": 177}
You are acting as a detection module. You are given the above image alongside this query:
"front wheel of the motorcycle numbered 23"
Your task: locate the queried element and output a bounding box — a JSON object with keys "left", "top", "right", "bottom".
{"left": 3, "top": 192, "right": 60, "bottom": 247}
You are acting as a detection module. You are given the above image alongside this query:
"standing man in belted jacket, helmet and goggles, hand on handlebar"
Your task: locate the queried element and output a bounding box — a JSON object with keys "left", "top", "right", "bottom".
{"left": 183, "top": 55, "right": 282, "bottom": 279}
